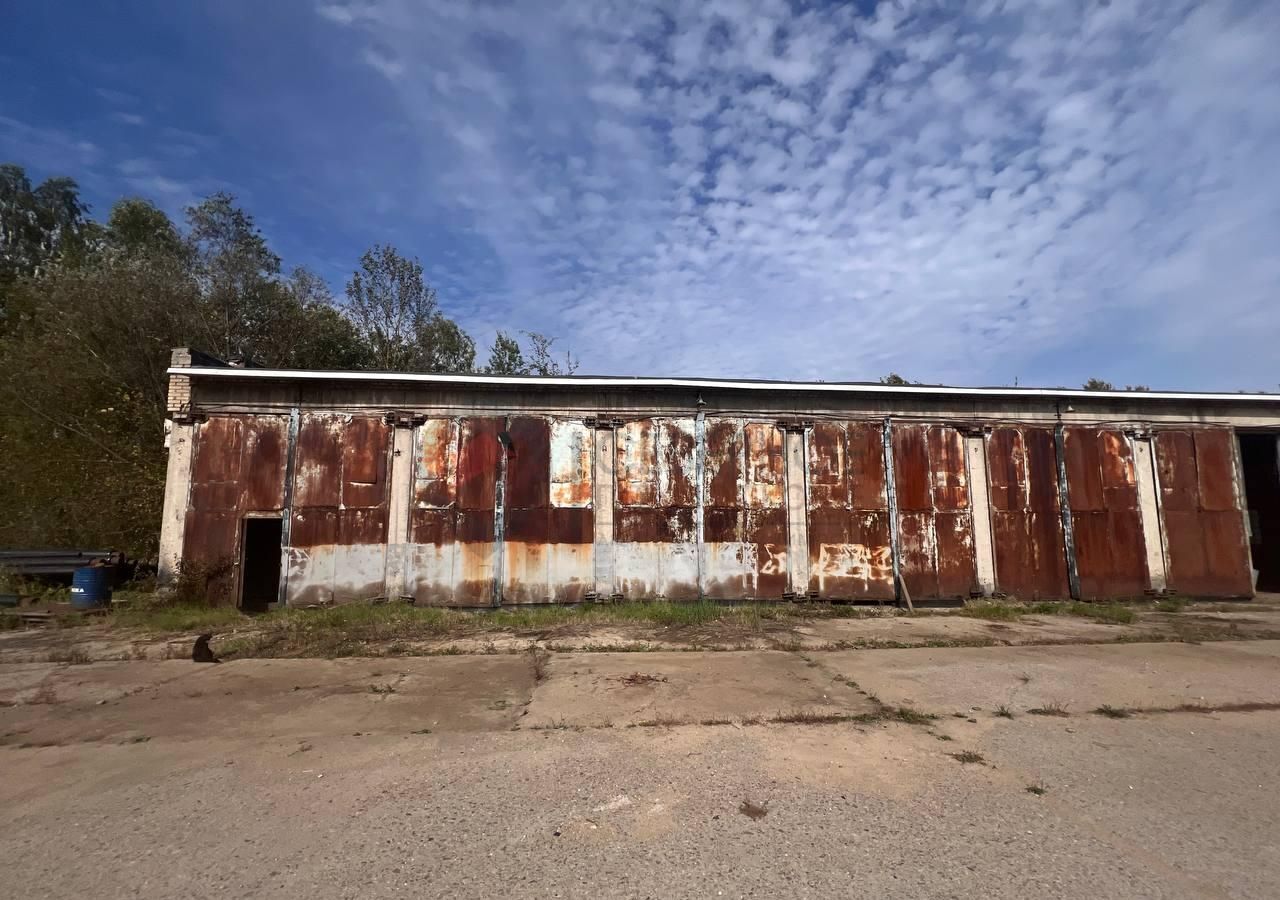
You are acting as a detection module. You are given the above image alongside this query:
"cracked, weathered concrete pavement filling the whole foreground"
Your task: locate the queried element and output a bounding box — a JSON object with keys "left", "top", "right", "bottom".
{"left": 0, "top": 641, "right": 1280, "bottom": 899}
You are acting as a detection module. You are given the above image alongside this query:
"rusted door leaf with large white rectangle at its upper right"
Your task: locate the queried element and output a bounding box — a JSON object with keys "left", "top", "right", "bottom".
{"left": 502, "top": 416, "right": 594, "bottom": 604}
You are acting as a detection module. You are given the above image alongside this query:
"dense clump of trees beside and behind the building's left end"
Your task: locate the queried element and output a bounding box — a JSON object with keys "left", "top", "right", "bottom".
{"left": 0, "top": 166, "right": 577, "bottom": 557}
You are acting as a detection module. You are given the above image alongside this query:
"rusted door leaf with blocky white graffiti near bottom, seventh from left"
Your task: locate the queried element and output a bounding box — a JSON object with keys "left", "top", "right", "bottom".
{"left": 808, "top": 422, "right": 893, "bottom": 599}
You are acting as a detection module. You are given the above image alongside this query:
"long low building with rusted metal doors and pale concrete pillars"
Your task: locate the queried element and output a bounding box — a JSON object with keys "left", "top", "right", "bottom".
{"left": 161, "top": 350, "right": 1280, "bottom": 609}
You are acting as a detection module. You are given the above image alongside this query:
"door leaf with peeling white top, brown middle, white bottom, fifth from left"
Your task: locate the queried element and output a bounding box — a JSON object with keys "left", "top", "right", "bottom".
{"left": 612, "top": 419, "right": 698, "bottom": 600}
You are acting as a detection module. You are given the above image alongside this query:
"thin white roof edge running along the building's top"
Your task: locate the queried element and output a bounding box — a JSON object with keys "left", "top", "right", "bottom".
{"left": 168, "top": 366, "right": 1280, "bottom": 403}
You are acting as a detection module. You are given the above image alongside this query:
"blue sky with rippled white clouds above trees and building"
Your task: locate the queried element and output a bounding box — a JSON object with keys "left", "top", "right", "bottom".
{"left": 0, "top": 0, "right": 1280, "bottom": 390}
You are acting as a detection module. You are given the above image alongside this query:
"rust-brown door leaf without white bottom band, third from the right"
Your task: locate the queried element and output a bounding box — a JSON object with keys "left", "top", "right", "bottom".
{"left": 987, "top": 425, "right": 1070, "bottom": 599}
